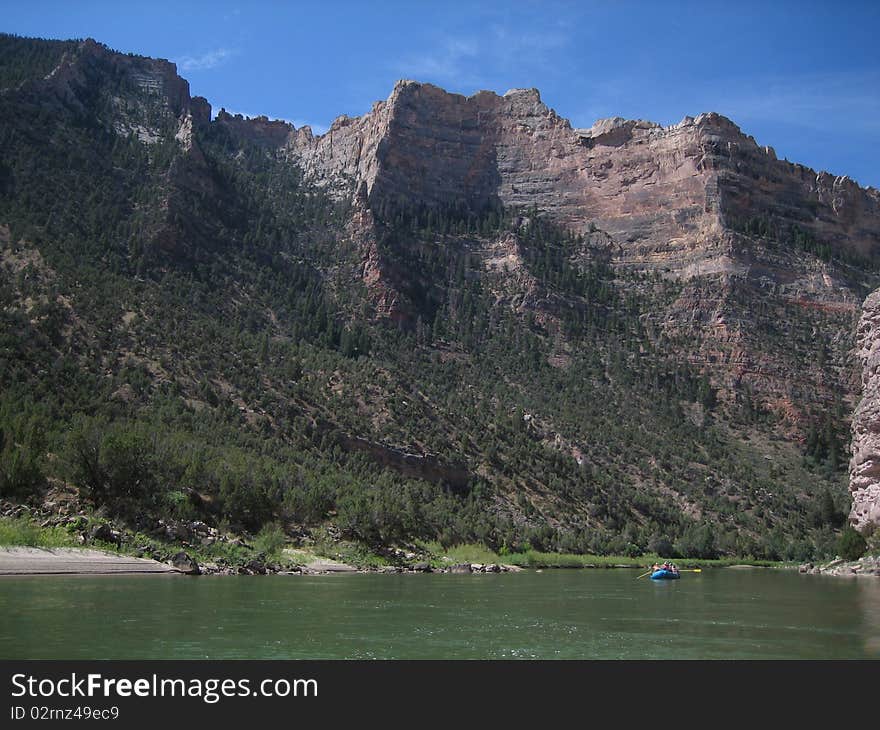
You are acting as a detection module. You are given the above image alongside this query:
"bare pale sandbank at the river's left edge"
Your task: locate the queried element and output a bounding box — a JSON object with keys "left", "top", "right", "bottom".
{"left": 0, "top": 547, "right": 179, "bottom": 576}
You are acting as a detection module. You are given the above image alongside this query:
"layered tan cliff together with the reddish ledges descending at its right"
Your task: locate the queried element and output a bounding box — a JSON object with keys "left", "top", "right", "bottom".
{"left": 272, "top": 81, "right": 880, "bottom": 423}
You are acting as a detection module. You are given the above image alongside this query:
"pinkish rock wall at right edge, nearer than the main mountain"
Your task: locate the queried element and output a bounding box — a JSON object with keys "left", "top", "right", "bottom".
{"left": 849, "top": 290, "right": 880, "bottom": 529}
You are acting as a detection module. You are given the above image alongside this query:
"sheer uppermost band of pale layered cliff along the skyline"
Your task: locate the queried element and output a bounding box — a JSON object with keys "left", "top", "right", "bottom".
{"left": 287, "top": 81, "right": 880, "bottom": 276}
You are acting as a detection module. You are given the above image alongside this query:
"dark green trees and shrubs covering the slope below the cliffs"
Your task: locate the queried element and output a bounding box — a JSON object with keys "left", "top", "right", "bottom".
{"left": 0, "top": 31, "right": 860, "bottom": 560}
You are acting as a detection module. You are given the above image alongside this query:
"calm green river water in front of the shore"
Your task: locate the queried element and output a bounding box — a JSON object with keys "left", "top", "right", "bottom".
{"left": 0, "top": 569, "right": 880, "bottom": 659}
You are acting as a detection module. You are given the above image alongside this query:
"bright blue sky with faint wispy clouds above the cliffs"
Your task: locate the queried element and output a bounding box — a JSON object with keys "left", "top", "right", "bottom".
{"left": 6, "top": 0, "right": 880, "bottom": 188}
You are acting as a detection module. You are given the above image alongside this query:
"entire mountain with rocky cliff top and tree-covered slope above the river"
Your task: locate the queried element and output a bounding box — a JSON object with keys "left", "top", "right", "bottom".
{"left": 0, "top": 31, "right": 880, "bottom": 558}
